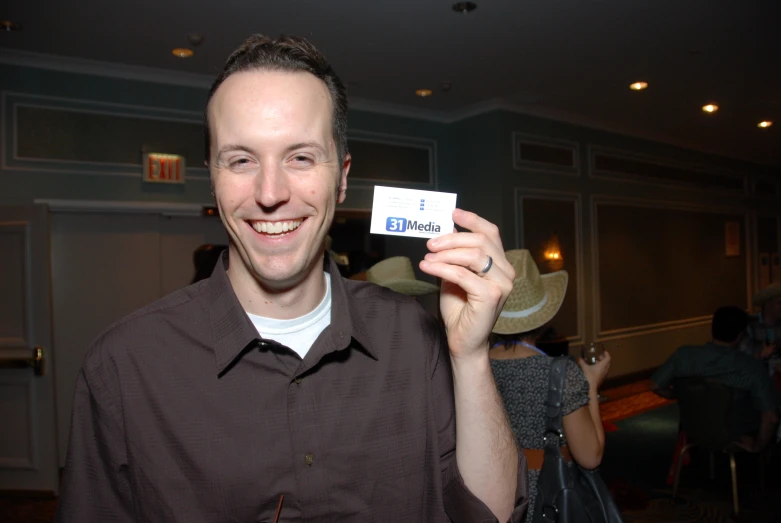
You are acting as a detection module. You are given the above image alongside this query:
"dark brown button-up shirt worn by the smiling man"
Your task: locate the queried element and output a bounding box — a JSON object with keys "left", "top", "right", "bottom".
{"left": 57, "top": 259, "right": 528, "bottom": 523}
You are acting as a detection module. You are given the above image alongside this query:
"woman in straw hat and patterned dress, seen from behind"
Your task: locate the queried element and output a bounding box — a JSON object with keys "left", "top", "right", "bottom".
{"left": 490, "top": 250, "right": 610, "bottom": 522}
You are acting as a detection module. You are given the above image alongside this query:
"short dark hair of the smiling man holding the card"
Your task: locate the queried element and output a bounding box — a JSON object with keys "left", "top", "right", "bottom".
{"left": 203, "top": 34, "right": 347, "bottom": 167}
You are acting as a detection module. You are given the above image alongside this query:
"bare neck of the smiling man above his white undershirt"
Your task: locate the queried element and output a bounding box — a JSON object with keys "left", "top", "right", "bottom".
{"left": 228, "top": 258, "right": 326, "bottom": 320}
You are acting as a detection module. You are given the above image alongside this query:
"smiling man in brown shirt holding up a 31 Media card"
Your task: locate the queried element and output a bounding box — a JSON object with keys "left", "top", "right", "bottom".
{"left": 58, "top": 36, "right": 528, "bottom": 523}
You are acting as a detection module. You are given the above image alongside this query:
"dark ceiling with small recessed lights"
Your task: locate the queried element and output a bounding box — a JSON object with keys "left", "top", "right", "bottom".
{"left": 0, "top": 0, "right": 781, "bottom": 166}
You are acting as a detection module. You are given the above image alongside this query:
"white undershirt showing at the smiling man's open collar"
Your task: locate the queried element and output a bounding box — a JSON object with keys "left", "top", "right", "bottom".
{"left": 247, "top": 271, "right": 331, "bottom": 359}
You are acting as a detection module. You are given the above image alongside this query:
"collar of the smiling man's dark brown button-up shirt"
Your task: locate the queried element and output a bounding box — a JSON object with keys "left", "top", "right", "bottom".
{"left": 205, "top": 250, "right": 377, "bottom": 374}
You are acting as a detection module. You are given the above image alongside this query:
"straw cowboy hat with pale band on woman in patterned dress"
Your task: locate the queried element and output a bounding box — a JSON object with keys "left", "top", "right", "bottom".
{"left": 493, "top": 249, "right": 569, "bottom": 334}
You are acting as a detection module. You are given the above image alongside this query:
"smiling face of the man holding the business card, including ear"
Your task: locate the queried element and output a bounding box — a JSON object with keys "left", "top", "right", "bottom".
{"left": 208, "top": 71, "right": 350, "bottom": 290}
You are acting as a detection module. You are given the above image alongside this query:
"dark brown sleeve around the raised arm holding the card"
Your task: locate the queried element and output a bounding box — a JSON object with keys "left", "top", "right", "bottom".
{"left": 432, "top": 331, "right": 529, "bottom": 523}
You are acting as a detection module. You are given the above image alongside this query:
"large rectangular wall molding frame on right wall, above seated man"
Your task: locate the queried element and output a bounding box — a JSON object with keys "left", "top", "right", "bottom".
{"left": 589, "top": 194, "right": 754, "bottom": 341}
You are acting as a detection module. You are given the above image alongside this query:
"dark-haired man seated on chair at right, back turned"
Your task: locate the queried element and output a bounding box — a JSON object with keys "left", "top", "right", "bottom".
{"left": 651, "top": 307, "right": 778, "bottom": 452}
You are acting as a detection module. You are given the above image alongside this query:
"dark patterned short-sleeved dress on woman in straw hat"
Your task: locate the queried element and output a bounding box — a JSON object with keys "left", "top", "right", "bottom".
{"left": 491, "top": 354, "right": 589, "bottom": 523}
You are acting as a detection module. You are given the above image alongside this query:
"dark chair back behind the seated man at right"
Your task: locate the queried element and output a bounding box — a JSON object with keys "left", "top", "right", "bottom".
{"left": 673, "top": 378, "right": 732, "bottom": 450}
